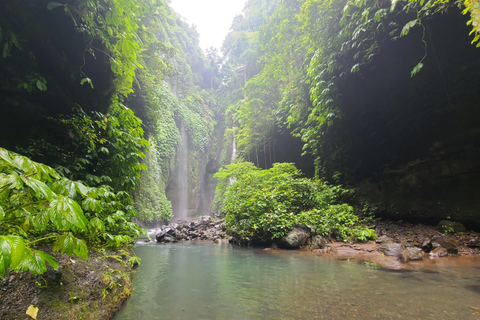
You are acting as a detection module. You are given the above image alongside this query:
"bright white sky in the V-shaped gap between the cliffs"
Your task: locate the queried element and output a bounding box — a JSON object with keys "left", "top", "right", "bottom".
{"left": 170, "top": 0, "right": 246, "bottom": 51}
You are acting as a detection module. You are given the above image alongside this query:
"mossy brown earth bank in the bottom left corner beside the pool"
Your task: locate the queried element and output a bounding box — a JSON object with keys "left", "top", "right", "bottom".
{"left": 0, "top": 249, "right": 132, "bottom": 320}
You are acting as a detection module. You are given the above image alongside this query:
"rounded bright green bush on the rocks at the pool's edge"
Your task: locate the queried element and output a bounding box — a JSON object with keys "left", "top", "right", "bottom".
{"left": 215, "top": 162, "right": 375, "bottom": 241}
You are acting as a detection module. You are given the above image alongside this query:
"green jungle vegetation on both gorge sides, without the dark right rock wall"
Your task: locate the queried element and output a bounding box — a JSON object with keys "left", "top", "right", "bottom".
{"left": 0, "top": 0, "right": 480, "bottom": 275}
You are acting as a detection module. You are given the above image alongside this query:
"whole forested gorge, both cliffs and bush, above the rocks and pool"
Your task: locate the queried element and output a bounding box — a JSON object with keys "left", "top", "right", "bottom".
{"left": 0, "top": 0, "right": 480, "bottom": 275}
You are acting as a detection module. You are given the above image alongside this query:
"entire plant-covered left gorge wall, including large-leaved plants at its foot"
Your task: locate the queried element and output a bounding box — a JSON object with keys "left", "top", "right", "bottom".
{"left": 0, "top": 0, "right": 215, "bottom": 275}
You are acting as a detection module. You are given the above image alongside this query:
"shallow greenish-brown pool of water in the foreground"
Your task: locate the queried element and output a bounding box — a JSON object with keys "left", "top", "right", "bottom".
{"left": 113, "top": 243, "right": 480, "bottom": 320}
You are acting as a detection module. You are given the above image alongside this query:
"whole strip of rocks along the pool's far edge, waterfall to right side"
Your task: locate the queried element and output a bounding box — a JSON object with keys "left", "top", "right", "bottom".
{"left": 151, "top": 217, "right": 480, "bottom": 270}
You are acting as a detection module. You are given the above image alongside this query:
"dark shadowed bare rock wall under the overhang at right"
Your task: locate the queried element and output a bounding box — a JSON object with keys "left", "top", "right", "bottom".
{"left": 322, "top": 10, "right": 480, "bottom": 229}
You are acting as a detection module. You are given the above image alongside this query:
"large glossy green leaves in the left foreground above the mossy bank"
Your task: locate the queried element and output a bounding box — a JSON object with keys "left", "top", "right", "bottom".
{"left": 0, "top": 148, "right": 141, "bottom": 276}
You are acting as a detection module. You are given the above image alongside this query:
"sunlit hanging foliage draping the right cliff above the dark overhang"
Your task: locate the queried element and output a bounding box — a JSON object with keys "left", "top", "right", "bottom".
{"left": 223, "top": 0, "right": 479, "bottom": 174}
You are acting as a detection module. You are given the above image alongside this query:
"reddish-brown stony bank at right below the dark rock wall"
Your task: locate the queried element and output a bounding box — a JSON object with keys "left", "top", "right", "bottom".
{"left": 292, "top": 220, "right": 480, "bottom": 270}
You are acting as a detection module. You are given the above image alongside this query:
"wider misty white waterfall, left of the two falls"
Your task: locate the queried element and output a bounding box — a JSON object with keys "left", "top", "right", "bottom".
{"left": 174, "top": 125, "right": 188, "bottom": 219}
